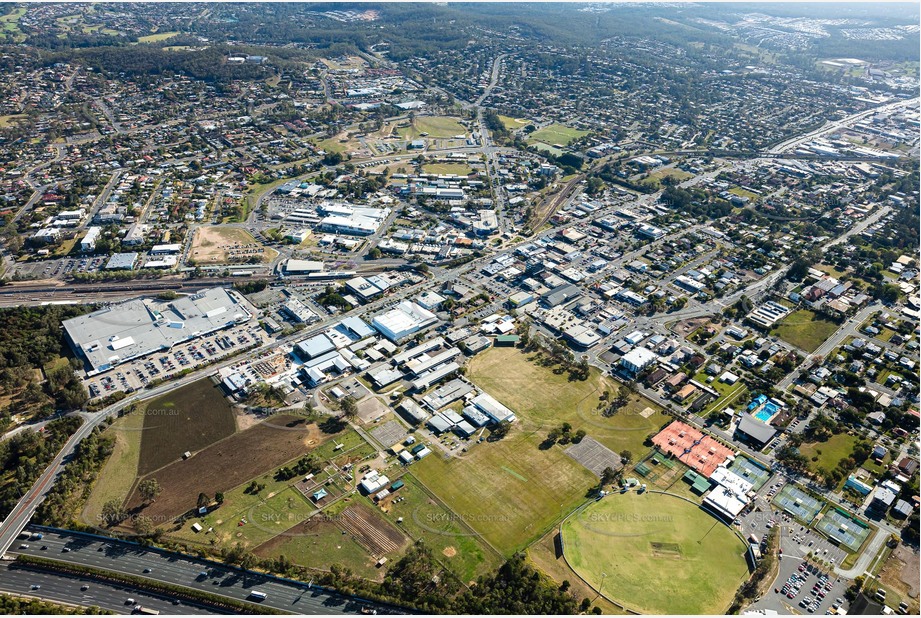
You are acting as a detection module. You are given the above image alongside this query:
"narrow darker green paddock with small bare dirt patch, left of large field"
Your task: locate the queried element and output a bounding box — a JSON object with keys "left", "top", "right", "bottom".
{"left": 381, "top": 474, "right": 502, "bottom": 582}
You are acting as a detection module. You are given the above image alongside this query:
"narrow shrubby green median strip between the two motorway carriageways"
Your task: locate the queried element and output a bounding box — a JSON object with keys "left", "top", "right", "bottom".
{"left": 16, "top": 555, "right": 288, "bottom": 614}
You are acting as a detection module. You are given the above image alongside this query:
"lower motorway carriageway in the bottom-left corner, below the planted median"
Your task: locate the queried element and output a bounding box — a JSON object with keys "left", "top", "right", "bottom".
{"left": 0, "top": 563, "right": 225, "bottom": 616}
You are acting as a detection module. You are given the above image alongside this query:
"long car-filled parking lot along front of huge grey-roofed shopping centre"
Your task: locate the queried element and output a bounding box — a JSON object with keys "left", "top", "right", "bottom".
{"left": 85, "top": 322, "right": 265, "bottom": 399}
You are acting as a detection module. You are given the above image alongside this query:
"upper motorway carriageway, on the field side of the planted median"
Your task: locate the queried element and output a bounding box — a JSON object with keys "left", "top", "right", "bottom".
{"left": 0, "top": 529, "right": 387, "bottom": 615}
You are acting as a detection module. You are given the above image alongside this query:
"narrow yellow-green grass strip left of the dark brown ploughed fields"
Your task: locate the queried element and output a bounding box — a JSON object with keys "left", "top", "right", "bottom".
{"left": 80, "top": 413, "right": 144, "bottom": 526}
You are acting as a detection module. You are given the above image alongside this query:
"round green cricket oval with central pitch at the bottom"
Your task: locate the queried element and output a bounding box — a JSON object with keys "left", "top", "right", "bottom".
{"left": 562, "top": 492, "right": 748, "bottom": 614}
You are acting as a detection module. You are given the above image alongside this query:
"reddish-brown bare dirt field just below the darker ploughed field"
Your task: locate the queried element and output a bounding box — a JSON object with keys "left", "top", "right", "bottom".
{"left": 127, "top": 416, "right": 323, "bottom": 522}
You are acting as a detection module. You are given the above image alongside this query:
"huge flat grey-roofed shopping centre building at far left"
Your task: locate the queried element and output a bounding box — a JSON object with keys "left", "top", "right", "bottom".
{"left": 62, "top": 288, "right": 252, "bottom": 375}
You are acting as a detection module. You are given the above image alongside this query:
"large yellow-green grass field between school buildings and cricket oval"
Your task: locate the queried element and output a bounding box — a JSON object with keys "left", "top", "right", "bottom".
{"left": 412, "top": 424, "right": 597, "bottom": 556}
